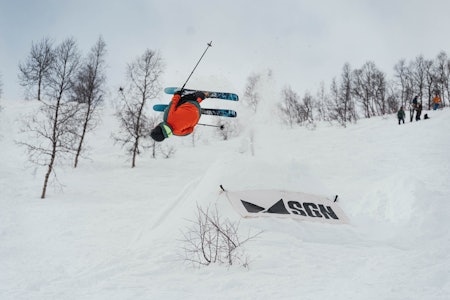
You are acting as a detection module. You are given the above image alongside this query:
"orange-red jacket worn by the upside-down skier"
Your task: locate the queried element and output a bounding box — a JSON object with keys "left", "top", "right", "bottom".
{"left": 164, "top": 92, "right": 205, "bottom": 135}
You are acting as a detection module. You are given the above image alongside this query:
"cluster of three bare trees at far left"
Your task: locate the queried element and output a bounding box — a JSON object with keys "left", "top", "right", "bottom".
{"left": 19, "top": 38, "right": 106, "bottom": 198}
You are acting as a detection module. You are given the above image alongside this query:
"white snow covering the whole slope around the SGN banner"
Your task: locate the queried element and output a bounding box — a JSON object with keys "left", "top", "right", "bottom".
{"left": 0, "top": 96, "right": 450, "bottom": 300}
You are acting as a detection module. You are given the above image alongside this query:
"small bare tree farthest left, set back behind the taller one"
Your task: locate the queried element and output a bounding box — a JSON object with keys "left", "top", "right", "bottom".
{"left": 19, "top": 38, "right": 55, "bottom": 101}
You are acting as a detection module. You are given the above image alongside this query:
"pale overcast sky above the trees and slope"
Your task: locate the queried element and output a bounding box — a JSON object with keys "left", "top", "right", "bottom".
{"left": 0, "top": 0, "right": 450, "bottom": 99}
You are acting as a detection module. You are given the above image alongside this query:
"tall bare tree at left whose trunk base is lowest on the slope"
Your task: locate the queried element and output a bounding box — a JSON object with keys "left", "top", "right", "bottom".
{"left": 20, "top": 38, "right": 80, "bottom": 199}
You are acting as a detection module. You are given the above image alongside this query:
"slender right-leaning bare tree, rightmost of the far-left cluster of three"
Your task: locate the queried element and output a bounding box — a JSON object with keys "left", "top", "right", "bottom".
{"left": 72, "top": 37, "right": 106, "bottom": 168}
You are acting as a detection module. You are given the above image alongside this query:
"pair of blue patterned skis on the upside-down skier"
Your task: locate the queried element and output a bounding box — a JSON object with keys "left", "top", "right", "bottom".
{"left": 153, "top": 87, "right": 239, "bottom": 118}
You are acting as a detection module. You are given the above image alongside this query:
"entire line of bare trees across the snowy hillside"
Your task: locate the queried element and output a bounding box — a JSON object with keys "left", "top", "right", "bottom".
{"left": 6, "top": 37, "right": 450, "bottom": 198}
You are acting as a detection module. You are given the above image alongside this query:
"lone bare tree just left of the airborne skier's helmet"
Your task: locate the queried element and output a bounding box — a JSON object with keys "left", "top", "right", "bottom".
{"left": 114, "top": 50, "right": 163, "bottom": 168}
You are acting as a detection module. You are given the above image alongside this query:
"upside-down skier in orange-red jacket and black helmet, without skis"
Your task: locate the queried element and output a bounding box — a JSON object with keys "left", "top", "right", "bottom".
{"left": 150, "top": 91, "right": 208, "bottom": 142}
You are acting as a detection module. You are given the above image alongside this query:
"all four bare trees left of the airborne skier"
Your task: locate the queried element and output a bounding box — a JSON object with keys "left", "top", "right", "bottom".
{"left": 19, "top": 37, "right": 167, "bottom": 198}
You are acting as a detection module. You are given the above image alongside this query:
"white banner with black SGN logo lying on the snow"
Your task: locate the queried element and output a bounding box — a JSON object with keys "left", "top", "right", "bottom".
{"left": 226, "top": 190, "right": 348, "bottom": 224}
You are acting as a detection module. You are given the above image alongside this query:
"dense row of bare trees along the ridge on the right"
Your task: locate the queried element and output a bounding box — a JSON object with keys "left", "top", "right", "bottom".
{"left": 244, "top": 52, "right": 450, "bottom": 126}
